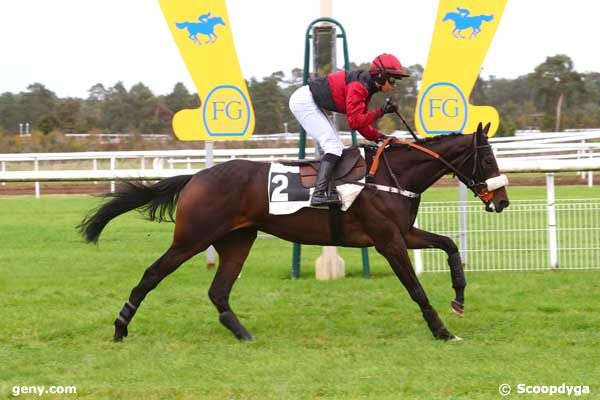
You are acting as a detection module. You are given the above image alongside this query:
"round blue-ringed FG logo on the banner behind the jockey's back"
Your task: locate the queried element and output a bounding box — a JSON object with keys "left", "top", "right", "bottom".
{"left": 202, "top": 85, "right": 251, "bottom": 136}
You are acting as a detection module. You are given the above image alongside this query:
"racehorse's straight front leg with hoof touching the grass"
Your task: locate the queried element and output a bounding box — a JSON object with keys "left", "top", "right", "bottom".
{"left": 375, "top": 234, "right": 456, "bottom": 340}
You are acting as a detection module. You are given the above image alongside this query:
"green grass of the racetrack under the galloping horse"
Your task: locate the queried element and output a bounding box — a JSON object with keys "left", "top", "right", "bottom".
{"left": 0, "top": 193, "right": 600, "bottom": 400}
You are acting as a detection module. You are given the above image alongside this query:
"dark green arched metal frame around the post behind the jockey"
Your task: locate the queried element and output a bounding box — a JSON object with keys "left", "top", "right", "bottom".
{"left": 292, "top": 17, "right": 371, "bottom": 279}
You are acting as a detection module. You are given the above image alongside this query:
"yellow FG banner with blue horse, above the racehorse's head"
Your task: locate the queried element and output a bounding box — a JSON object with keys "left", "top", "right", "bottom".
{"left": 415, "top": 0, "right": 507, "bottom": 136}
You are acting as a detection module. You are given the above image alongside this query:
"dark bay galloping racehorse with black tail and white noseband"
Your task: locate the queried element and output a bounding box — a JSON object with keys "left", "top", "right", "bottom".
{"left": 78, "top": 124, "right": 509, "bottom": 341}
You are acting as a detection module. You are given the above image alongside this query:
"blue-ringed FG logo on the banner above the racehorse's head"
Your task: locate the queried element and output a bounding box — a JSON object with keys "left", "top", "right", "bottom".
{"left": 419, "top": 82, "right": 468, "bottom": 135}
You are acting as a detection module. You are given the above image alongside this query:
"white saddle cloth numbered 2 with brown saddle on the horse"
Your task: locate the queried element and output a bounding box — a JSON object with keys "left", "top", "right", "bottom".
{"left": 267, "top": 148, "right": 367, "bottom": 215}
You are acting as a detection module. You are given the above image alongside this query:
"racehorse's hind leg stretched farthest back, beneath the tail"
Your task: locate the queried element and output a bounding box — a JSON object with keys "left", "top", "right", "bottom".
{"left": 113, "top": 239, "right": 208, "bottom": 342}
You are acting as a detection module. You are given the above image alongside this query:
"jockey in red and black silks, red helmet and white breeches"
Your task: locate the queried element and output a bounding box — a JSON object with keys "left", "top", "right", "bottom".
{"left": 290, "top": 53, "right": 409, "bottom": 206}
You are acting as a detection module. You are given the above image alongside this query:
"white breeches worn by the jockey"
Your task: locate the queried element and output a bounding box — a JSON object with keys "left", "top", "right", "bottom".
{"left": 290, "top": 85, "right": 344, "bottom": 156}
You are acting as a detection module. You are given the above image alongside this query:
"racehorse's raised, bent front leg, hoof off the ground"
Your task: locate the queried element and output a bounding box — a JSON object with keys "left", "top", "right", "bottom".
{"left": 404, "top": 226, "right": 467, "bottom": 317}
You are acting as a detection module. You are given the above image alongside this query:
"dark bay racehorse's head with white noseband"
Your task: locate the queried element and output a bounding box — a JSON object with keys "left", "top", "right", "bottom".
{"left": 458, "top": 123, "right": 509, "bottom": 212}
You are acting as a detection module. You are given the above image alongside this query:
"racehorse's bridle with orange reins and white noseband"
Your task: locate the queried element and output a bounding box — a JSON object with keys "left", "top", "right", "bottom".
{"left": 368, "top": 133, "right": 508, "bottom": 207}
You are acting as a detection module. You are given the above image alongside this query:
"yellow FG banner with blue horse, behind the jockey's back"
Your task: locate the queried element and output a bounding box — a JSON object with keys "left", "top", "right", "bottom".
{"left": 159, "top": 0, "right": 254, "bottom": 140}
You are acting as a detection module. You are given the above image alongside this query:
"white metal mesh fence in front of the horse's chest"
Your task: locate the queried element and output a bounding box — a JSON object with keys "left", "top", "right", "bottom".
{"left": 413, "top": 199, "right": 600, "bottom": 272}
